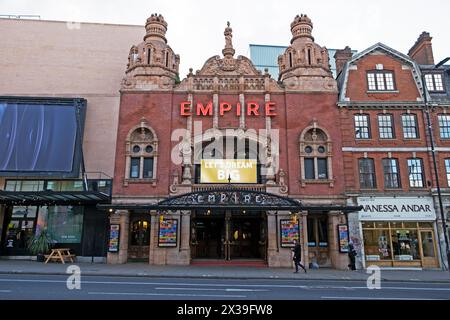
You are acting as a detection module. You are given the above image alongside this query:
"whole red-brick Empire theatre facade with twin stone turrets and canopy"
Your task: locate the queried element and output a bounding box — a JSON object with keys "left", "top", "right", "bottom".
{"left": 101, "top": 14, "right": 359, "bottom": 269}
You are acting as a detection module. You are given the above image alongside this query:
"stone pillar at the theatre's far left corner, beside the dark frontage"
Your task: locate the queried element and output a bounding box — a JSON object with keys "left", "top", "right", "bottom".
{"left": 106, "top": 210, "right": 130, "bottom": 264}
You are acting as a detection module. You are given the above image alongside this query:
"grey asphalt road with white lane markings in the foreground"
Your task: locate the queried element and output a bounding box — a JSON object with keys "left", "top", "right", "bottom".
{"left": 0, "top": 274, "right": 450, "bottom": 300}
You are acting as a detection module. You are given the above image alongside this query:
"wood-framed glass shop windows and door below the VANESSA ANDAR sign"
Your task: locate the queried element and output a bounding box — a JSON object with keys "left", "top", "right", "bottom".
{"left": 362, "top": 221, "right": 438, "bottom": 267}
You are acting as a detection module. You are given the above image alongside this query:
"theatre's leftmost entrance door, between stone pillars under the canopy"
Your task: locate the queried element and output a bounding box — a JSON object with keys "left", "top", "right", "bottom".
{"left": 128, "top": 216, "right": 150, "bottom": 261}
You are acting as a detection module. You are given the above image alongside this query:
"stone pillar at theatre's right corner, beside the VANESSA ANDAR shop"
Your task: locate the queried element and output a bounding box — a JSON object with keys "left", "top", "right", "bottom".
{"left": 328, "top": 211, "right": 350, "bottom": 270}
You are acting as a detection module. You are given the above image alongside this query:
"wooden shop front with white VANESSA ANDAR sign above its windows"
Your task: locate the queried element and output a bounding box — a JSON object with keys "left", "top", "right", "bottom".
{"left": 358, "top": 197, "right": 439, "bottom": 268}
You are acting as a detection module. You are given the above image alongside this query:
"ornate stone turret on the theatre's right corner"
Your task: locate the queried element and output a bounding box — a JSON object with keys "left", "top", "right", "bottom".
{"left": 278, "top": 14, "right": 337, "bottom": 92}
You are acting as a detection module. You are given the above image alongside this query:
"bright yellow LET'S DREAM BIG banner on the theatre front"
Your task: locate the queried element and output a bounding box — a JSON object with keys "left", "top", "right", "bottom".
{"left": 200, "top": 159, "right": 258, "bottom": 183}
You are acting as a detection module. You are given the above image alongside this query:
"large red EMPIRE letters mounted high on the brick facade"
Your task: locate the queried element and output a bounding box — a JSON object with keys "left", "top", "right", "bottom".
{"left": 180, "top": 101, "right": 277, "bottom": 117}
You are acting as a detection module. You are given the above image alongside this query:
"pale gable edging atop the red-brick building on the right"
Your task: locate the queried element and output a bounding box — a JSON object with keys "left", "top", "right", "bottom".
{"left": 337, "top": 42, "right": 429, "bottom": 103}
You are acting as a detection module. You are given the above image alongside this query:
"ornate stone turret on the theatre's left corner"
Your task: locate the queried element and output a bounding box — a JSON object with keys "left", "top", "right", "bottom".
{"left": 122, "top": 13, "right": 180, "bottom": 90}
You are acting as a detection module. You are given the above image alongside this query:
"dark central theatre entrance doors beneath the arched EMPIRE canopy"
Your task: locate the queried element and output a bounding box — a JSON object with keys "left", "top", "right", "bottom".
{"left": 191, "top": 210, "right": 267, "bottom": 260}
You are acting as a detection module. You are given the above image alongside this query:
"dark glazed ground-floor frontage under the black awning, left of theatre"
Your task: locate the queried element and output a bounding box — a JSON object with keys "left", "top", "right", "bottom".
{"left": 0, "top": 180, "right": 111, "bottom": 257}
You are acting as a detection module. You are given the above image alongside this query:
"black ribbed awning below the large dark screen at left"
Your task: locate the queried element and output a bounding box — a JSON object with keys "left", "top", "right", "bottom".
{"left": 0, "top": 191, "right": 111, "bottom": 206}
